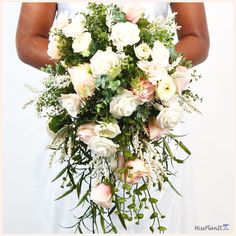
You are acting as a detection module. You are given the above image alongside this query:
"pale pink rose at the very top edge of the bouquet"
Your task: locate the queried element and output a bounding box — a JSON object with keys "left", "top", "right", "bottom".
{"left": 123, "top": 4, "right": 144, "bottom": 24}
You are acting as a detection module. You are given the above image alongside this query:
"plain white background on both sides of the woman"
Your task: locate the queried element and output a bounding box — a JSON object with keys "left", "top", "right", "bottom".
{"left": 2, "top": 2, "right": 236, "bottom": 233}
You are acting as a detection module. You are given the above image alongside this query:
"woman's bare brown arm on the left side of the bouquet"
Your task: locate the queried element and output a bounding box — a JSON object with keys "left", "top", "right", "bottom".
{"left": 16, "top": 3, "right": 57, "bottom": 69}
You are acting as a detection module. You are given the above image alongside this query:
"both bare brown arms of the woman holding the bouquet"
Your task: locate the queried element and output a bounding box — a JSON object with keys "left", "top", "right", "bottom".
{"left": 16, "top": 3, "right": 210, "bottom": 69}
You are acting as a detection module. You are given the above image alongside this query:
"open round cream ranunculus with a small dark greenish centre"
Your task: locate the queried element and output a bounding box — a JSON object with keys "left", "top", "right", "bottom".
{"left": 156, "top": 77, "right": 176, "bottom": 101}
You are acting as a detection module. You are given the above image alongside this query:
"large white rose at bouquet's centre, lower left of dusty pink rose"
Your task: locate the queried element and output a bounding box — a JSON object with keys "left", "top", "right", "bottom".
{"left": 110, "top": 89, "right": 142, "bottom": 119}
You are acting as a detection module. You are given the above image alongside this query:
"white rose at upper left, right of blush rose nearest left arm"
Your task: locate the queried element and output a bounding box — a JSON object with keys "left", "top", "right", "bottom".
{"left": 72, "top": 32, "right": 92, "bottom": 56}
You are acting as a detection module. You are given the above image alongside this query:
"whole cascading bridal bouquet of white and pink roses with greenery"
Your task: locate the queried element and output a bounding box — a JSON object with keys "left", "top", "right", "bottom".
{"left": 26, "top": 3, "right": 203, "bottom": 233}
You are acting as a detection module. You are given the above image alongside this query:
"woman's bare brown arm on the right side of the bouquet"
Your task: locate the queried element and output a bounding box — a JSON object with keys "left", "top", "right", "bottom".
{"left": 170, "top": 3, "right": 210, "bottom": 65}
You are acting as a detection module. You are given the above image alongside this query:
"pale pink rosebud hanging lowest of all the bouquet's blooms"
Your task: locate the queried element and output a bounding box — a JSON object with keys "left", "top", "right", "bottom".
{"left": 91, "top": 183, "right": 112, "bottom": 208}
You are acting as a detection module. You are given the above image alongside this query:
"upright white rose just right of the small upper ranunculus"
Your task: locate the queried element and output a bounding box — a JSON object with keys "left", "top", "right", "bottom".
{"left": 151, "top": 41, "right": 170, "bottom": 66}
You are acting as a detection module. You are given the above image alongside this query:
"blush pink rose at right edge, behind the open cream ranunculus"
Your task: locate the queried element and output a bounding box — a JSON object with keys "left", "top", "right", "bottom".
{"left": 173, "top": 66, "right": 190, "bottom": 95}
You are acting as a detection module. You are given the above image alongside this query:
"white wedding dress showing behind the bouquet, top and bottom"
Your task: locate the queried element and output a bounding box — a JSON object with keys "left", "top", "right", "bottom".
{"left": 31, "top": 2, "right": 192, "bottom": 233}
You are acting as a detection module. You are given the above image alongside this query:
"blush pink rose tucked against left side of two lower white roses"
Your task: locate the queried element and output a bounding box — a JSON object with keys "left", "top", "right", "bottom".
{"left": 77, "top": 122, "right": 96, "bottom": 144}
